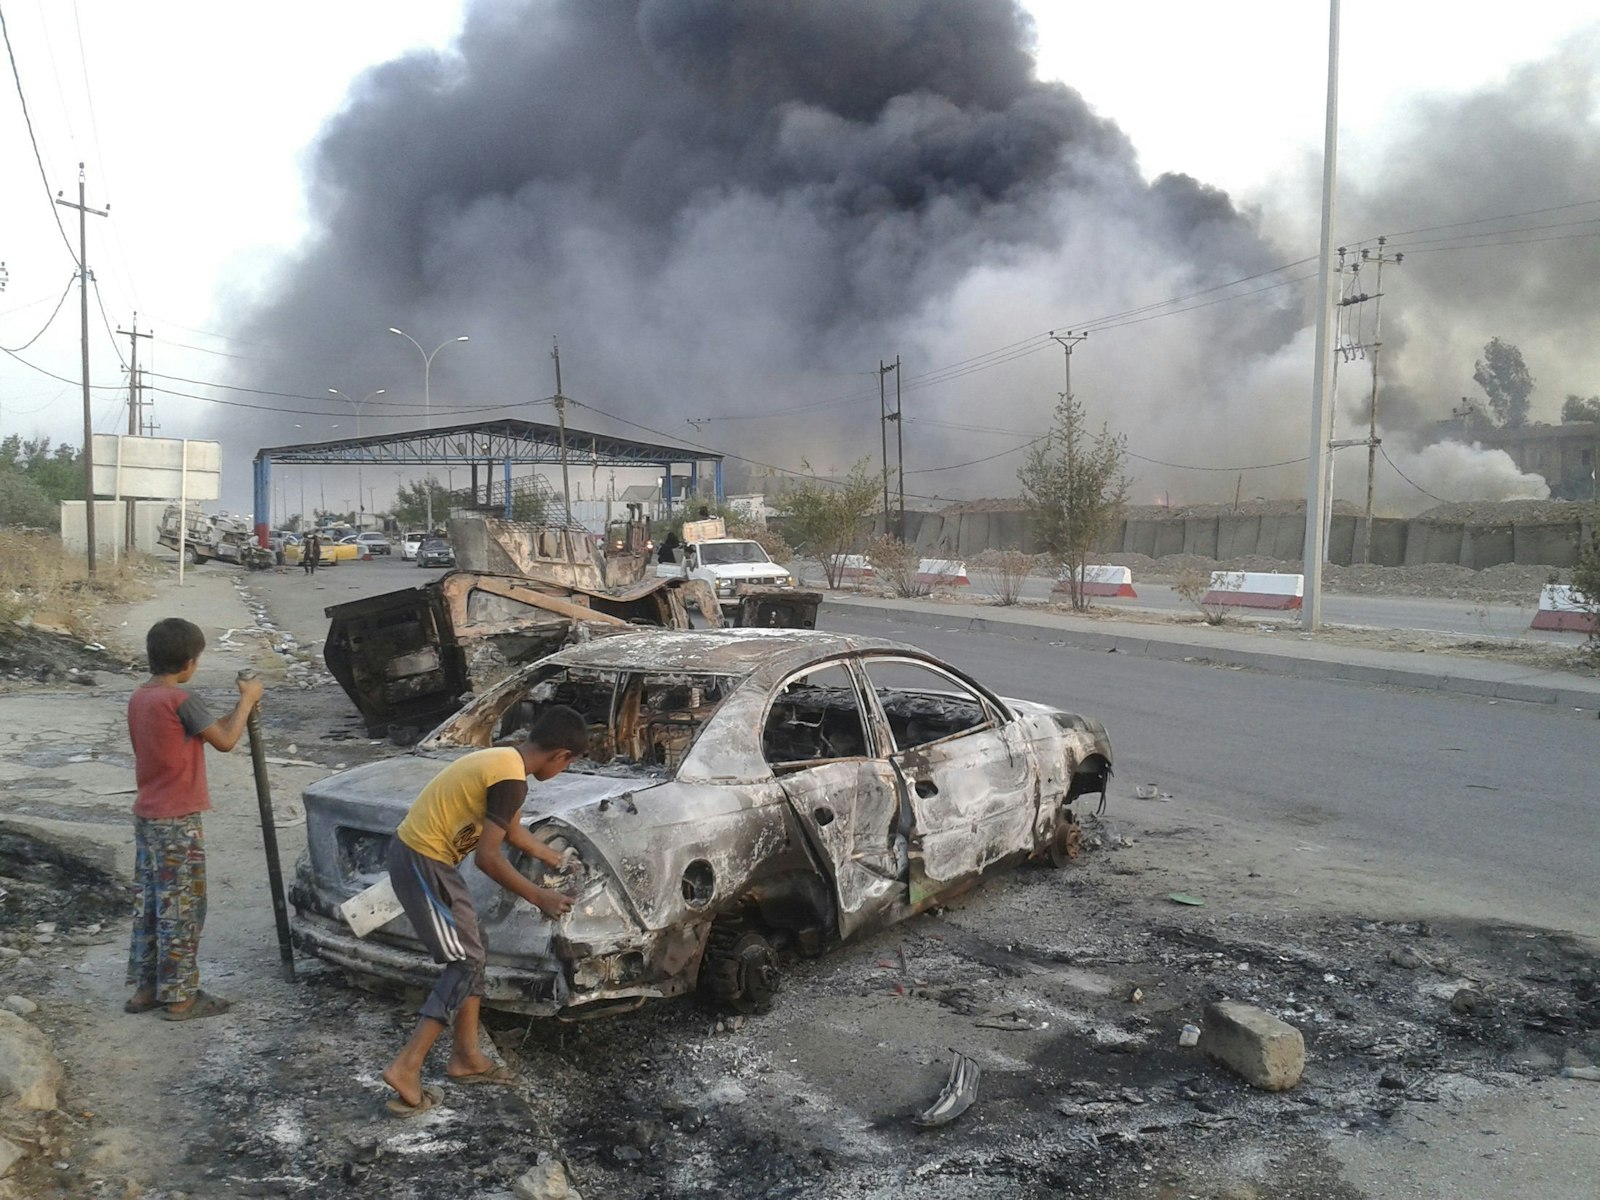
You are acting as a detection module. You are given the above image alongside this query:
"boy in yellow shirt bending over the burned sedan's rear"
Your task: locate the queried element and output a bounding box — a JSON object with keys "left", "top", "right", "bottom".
{"left": 384, "top": 706, "right": 589, "bottom": 1117}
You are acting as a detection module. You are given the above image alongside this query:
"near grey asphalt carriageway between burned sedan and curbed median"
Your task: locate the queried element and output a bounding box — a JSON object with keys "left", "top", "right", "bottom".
{"left": 256, "top": 558, "right": 1600, "bottom": 934}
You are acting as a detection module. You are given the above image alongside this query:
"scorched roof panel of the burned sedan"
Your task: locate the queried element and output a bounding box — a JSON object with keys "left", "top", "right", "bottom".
{"left": 544, "top": 629, "right": 923, "bottom": 675}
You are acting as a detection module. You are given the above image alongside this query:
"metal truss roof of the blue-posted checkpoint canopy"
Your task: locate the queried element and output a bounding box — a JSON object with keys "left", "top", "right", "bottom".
{"left": 256, "top": 419, "right": 722, "bottom": 467}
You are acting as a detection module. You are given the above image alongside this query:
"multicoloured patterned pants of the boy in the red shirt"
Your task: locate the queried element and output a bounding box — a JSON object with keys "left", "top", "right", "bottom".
{"left": 128, "top": 813, "right": 205, "bottom": 1005}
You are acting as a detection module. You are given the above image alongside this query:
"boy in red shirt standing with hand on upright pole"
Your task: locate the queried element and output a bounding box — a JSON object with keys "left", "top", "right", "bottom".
{"left": 123, "top": 616, "right": 261, "bottom": 1021}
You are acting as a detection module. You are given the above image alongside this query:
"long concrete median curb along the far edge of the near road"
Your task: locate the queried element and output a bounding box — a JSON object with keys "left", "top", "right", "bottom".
{"left": 822, "top": 597, "right": 1600, "bottom": 710}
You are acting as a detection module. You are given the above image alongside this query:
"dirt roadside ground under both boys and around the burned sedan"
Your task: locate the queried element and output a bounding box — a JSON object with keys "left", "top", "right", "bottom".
{"left": 0, "top": 571, "right": 1600, "bottom": 1200}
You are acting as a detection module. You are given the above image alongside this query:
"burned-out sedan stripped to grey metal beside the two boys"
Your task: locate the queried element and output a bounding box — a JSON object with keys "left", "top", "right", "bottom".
{"left": 291, "top": 629, "right": 1112, "bottom": 1016}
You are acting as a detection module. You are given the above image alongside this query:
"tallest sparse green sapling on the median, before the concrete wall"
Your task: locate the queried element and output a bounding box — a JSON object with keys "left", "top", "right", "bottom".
{"left": 1016, "top": 395, "right": 1128, "bottom": 611}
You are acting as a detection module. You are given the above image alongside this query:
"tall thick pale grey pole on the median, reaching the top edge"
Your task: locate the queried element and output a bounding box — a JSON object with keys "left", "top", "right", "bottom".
{"left": 1301, "top": 0, "right": 1339, "bottom": 632}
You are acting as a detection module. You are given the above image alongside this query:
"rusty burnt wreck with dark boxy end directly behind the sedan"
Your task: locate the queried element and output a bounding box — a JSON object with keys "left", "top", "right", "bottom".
{"left": 323, "top": 571, "right": 715, "bottom": 741}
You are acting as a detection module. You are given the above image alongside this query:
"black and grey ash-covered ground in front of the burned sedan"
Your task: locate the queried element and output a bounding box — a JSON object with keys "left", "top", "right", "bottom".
{"left": 156, "top": 853, "right": 1600, "bottom": 1200}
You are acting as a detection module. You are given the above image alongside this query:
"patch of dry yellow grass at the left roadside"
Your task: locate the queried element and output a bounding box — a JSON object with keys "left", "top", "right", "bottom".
{"left": 0, "top": 528, "right": 158, "bottom": 638}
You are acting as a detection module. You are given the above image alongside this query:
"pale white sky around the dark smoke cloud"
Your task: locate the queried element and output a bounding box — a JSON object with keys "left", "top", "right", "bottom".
{"left": 0, "top": 0, "right": 1600, "bottom": 518}
